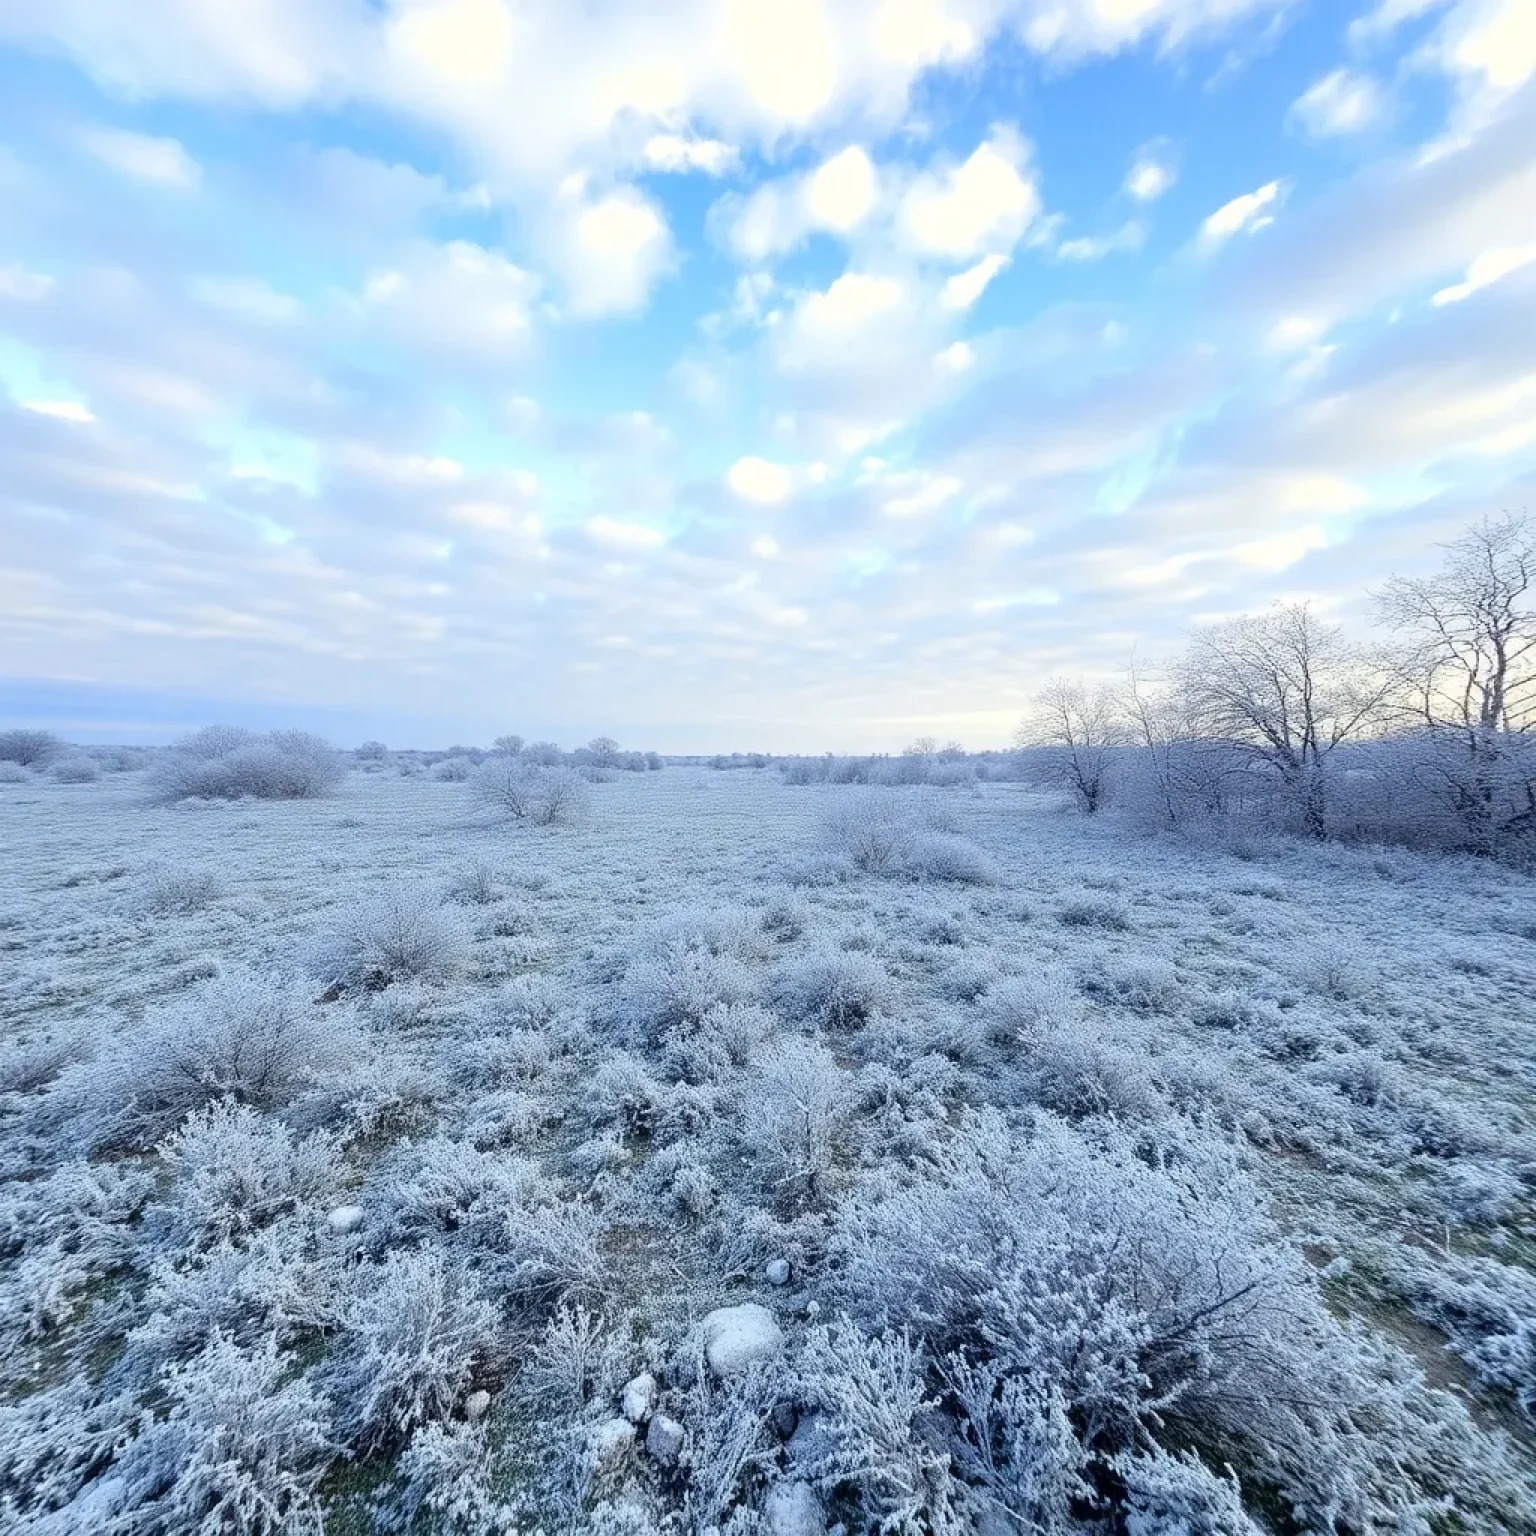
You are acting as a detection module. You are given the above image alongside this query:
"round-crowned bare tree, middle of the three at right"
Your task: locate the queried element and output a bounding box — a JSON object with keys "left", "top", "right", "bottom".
{"left": 1180, "top": 604, "right": 1393, "bottom": 837}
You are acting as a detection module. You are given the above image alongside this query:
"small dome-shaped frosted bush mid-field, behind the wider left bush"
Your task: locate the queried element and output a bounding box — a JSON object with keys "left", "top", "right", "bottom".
{"left": 310, "top": 889, "right": 468, "bottom": 992}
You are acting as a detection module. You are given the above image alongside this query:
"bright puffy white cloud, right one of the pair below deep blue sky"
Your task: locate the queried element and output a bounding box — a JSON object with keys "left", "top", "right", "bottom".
{"left": 902, "top": 126, "right": 1040, "bottom": 260}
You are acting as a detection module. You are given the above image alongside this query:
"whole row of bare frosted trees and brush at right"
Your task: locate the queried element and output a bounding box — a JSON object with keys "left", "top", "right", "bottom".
{"left": 1018, "top": 513, "right": 1536, "bottom": 862}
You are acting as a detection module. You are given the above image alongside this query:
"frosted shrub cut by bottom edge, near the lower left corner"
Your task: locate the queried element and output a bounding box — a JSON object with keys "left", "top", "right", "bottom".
{"left": 104, "top": 1338, "right": 338, "bottom": 1536}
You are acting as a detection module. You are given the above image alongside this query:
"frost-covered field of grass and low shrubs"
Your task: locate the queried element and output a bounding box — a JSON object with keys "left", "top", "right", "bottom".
{"left": 0, "top": 768, "right": 1536, "bottom": 1536}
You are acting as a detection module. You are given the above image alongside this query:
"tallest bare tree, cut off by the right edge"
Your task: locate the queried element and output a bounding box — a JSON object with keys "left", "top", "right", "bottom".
{"left": 1378, "top": 513, "right": 1536, "bottom": 856}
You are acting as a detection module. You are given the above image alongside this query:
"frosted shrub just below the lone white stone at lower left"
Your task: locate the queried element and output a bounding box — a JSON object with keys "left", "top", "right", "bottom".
{"left": 323, "top": 1249, "right": 501, "bottom": 1450}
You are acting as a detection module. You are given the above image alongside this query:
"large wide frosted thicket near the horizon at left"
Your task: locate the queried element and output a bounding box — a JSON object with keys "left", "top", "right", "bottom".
{"left": 151, "top": 725, "right": 344, "bottom": 803}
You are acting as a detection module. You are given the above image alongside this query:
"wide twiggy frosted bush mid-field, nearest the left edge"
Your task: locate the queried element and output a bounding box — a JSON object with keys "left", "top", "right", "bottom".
{"left": 96, "top": 974, "right": 344, "bottom": 1144}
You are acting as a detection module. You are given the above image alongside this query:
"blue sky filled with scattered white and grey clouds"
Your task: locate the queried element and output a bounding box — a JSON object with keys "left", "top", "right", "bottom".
{"left": 0, "top": 0, "right": 1536, "bottom": 751}
